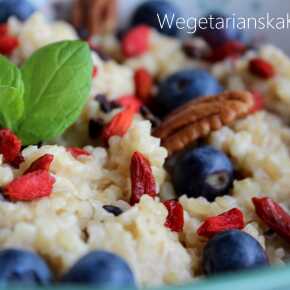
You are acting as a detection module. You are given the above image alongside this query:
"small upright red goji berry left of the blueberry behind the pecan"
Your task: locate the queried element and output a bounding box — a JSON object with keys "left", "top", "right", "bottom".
{"left": 134, "top": 68, "right": 153, "bottom": 103}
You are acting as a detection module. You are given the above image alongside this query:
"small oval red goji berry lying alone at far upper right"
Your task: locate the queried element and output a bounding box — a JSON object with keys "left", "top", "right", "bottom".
{"left": 249, "top": 57, "right": 275, "bottom": 79}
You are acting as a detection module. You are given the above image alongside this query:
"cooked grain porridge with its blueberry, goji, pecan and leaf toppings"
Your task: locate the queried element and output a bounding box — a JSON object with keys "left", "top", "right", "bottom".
{"left": 0, "top": 1, "right": 290, "bottom": 287}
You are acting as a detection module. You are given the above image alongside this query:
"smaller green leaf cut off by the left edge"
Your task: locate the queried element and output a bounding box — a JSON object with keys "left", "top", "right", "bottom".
{"left": 0, "top": 55, "right": 24, "bottom": 130}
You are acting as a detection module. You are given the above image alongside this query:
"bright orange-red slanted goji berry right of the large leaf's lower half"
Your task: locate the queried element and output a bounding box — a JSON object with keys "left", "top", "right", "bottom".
{"left": 102, "top": 106, "right": 136, "bottom": 144}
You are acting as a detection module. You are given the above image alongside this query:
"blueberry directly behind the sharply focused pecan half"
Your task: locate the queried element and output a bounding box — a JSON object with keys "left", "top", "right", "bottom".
{"left": 155, "top": 69, "right": 222, "bottom": 115}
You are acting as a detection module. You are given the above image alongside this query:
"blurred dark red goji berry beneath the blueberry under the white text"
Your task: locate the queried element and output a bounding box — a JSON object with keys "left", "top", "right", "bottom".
{"left": 208, "top": 41, "right": 246, "bottom": 62}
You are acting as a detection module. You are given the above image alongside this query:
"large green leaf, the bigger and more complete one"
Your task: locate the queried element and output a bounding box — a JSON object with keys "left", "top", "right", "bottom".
{"left": 17, "top": 41, "right": 93, "bottom": 145}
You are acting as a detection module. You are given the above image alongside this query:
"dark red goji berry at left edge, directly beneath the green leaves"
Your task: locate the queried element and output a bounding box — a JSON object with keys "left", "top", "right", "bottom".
{"left": 0, "top": 129, "right": 21, "bottom": 163}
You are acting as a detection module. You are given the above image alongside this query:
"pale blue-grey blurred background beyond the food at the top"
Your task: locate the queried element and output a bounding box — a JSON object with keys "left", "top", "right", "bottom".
{"left": 0, "top": 0, "right": 290, "bottom": 54}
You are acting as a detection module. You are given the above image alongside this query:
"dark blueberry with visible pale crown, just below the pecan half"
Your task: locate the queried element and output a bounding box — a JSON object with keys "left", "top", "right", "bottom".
{"left": 172, "top": 146, "right": 234, "bottom": 201}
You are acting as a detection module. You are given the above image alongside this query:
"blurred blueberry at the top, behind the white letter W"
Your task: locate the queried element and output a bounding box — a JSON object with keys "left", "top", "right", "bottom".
{"left": 131, "top": 0, "right": 180, "bottom": 36}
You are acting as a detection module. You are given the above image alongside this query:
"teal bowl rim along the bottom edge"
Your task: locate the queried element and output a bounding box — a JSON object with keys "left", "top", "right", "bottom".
{"left": 0, "top": 264, "right": 290, "bottom": 290}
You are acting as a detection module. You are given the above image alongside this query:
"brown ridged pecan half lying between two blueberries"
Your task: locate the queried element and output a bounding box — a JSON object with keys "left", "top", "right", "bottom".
{"left": 153, "top": 91, "right": 254, "bottom": 154}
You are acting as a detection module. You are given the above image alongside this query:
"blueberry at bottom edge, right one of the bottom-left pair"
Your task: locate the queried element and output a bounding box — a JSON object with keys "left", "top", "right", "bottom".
{"left": 61, "top": 251, "right": 135, "bottom": 289}
